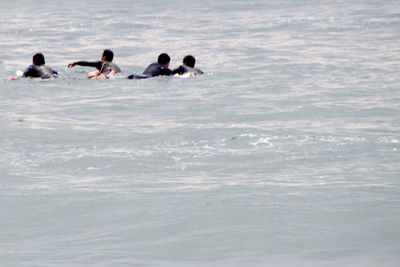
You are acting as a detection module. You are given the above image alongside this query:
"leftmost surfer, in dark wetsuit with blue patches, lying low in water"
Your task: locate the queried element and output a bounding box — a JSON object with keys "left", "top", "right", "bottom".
{"left": 4, "top": 53, "right": 58, "bottom": 80}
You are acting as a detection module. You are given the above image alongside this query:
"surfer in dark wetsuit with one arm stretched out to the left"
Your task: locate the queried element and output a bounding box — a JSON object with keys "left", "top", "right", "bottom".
{"left": 68, "top": 49, "right": 121, "bottom": 79}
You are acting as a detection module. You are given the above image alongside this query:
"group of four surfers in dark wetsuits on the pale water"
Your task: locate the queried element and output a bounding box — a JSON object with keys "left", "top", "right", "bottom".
{"left": 4, "top": 49, "right": 204, "bottom": 80}
